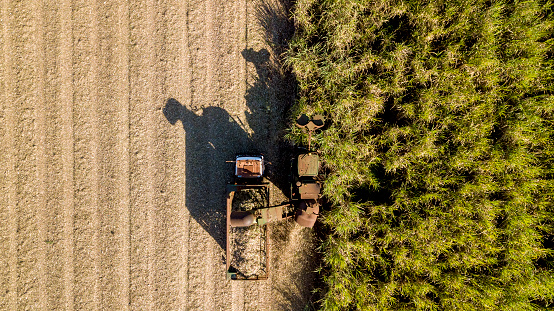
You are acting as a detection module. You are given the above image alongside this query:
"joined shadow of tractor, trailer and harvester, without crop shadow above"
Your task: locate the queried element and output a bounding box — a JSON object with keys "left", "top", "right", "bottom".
{"left": 163, "top": 49, "right": 290, "bottom": 249}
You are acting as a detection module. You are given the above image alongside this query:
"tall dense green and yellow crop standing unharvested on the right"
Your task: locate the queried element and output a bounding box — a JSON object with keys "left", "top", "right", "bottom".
{"left": 286, "top": 0, "right": 554, "bottom": 310}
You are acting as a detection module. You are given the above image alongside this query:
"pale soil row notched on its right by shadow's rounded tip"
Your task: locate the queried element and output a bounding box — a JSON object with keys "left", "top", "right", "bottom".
{"left": 150, "top": 1, "right": 185, "bottom": 310}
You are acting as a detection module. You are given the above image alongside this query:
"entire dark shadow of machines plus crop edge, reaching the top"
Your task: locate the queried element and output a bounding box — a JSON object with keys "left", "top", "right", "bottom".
{"left": 163, "top": 1, "right": 295, "bottom": 249}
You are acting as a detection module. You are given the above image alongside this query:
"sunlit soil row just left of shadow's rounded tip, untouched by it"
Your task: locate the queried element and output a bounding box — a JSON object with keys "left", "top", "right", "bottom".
{"left": 129, "top": 0, "right": 155, "bottom": 310}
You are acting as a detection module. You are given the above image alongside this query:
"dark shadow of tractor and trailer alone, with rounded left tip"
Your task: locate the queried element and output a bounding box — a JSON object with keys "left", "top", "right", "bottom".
{"left": 163, "top": 98, "right": 254, "bottom": 248}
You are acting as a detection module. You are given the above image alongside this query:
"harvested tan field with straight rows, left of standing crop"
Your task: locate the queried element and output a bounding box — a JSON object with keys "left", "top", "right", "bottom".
{"left": 0, "top": 0, "right": 314, "bottom": 310}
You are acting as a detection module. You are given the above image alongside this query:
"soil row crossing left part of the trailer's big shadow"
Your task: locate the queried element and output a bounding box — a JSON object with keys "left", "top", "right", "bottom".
{"left": 184, "top": 0, "right": 215, "bottom": 310}
